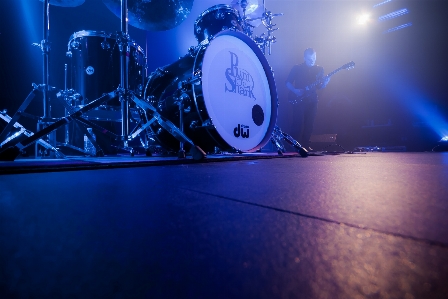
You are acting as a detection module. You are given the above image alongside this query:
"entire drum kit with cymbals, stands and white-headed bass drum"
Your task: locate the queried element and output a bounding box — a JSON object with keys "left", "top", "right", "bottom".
{"left": 0, "top": 0, "right": 307, "bottom": 160}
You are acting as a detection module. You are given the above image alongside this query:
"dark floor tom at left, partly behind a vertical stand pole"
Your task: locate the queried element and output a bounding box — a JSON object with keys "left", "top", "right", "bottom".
{"left": 67, "top": 30, "right": 146, "bottom": 105}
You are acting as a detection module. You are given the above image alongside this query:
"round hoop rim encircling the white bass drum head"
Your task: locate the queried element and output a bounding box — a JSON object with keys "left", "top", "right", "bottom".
{"left": 192, "top": 30, "right": 278, "bottom": 152}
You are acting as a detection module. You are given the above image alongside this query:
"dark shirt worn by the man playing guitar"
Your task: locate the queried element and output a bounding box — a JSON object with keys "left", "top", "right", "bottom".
{"left": 286, "top": 62, "right": 324, "bottom": 102}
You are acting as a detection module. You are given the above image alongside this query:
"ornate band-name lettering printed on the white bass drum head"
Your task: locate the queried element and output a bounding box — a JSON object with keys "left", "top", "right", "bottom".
{"left": 225, "top": 51, "right": 256, "bottom": 100}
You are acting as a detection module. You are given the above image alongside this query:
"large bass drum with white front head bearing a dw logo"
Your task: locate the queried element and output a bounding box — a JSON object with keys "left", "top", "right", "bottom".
{"left": 144, "top": 30, "right": 278, "bottom": 153}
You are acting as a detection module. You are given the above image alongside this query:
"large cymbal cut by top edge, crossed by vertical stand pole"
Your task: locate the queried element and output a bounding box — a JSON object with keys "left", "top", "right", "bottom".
{"left": 103, "top": 0, "right": 193, "bottom": 31}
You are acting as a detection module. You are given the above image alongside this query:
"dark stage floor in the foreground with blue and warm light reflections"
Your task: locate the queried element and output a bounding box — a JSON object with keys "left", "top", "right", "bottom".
{"left": 0, "top": 152, "right": 448, "bottom": 299}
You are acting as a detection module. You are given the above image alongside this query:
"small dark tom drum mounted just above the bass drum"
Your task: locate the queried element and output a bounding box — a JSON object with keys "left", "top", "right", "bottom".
{"left": 194, "top": 4, "right": 242, "bottom": 43}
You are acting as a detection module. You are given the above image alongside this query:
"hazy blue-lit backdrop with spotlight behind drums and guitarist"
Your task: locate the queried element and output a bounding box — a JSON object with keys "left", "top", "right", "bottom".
{"left": 0, "top": 0, "right": 448, "bottom": 151}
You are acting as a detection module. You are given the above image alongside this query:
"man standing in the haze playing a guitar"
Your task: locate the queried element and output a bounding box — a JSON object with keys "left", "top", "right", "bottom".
{"left": 286, "top": 48, "right": 330, "bottom": 150}
